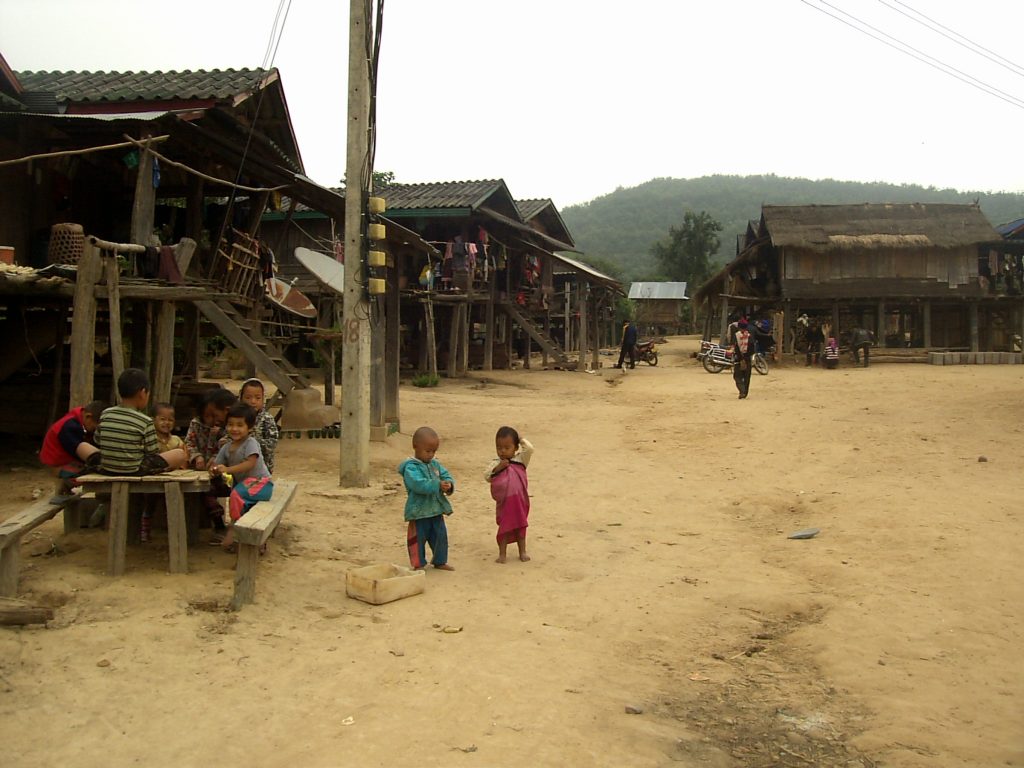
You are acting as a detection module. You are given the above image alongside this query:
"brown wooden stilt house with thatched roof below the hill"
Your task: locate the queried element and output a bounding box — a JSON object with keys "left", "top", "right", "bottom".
{"left": 694, "top": 204, "right": 1024, "bottom": 356}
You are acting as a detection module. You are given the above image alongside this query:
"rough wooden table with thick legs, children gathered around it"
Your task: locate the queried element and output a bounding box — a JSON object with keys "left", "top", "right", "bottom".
{"left": 77, "top": 469, "right": 210, "bottom": 577}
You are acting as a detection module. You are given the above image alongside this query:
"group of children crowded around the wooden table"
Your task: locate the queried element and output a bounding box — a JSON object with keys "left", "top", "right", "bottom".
{"left": 39, "top": 368, "right": 281, "bottom": 550}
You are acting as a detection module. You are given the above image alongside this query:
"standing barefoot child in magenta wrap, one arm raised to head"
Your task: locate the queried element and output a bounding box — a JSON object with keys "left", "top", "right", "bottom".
{"left": 486, "top": 427, "right": 534, "bottom": 562}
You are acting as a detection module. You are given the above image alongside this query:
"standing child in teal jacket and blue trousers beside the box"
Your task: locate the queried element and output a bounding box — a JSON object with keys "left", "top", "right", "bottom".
{"left": 398, "top": 427, "right": 455, "bottom": 570}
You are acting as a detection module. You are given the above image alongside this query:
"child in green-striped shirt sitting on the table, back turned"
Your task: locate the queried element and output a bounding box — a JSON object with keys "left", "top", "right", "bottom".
{"left": 96, "top": 368, "right": 188, "bottom": 476}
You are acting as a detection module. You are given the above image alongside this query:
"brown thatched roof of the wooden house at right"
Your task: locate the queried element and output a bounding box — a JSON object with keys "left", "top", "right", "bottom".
{"left": 762, "top": 203, "right": 999, "bottom": 252}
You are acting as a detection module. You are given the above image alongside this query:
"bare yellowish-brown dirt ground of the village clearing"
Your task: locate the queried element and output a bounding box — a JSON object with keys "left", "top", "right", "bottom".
{"left": 0, "top": 339, "right": 1024, "bottom": 768}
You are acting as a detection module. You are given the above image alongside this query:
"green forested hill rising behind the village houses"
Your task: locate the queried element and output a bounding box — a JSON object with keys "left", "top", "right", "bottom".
{"left": 561, "top": 176, "right": 1024, "bottom": 280}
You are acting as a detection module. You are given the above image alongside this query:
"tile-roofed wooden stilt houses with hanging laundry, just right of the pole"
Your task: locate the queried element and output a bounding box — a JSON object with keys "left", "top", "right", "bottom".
{"left": 379, "top": 179, "right": 622, "bottom": 377}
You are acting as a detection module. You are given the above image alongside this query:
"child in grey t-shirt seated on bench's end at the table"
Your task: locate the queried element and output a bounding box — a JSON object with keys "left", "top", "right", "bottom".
{"left": 210, "top": 402, "right": 273, "bottom": 552}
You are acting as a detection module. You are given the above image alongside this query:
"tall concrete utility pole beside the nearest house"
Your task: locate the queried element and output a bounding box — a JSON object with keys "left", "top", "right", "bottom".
{"left": 340, "top": 0, "right": 373, "bottom": 487}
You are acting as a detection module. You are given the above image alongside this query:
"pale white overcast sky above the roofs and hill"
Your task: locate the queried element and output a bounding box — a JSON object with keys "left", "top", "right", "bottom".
{"left": 0, "top": 0, "right": 1024, "bottom": 206}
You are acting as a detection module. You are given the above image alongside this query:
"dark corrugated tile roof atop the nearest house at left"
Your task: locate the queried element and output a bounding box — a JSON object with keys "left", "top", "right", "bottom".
{"left": 16, "top": 70, "right": 278, "bottom": 103}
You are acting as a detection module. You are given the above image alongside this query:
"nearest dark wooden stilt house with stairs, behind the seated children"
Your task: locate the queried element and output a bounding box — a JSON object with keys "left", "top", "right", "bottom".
{"left": 0, "top": 55, "right": 344, "bottom": 433}
